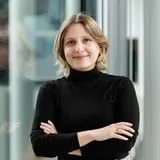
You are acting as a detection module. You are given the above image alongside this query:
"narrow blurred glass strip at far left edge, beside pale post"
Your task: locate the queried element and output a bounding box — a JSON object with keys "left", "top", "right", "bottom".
{"left": 0, "top": 0, "right": 9, "bottom": 160}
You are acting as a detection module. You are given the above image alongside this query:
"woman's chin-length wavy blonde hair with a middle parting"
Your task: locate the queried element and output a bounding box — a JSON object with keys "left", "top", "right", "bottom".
{"left": 53, "top": 13, "right": 108, "bottom": 77}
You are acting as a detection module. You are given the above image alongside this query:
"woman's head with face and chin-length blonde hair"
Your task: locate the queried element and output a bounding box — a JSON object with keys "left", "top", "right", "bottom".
{"left": 54, "top": 13, "right": 108, "bottom": 76}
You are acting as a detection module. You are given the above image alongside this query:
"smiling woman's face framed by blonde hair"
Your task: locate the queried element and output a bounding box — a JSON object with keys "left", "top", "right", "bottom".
{"left": 64, "top": 23, "right": 100, "bottom": 71}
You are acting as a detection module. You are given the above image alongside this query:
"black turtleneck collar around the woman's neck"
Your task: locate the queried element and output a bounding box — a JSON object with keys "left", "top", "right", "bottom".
{"left": 68, "top": 67, "right": 101, "bottom": 82}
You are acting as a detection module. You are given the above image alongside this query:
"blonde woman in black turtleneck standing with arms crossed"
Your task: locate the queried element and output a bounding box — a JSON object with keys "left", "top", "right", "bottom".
{"left": 30, "top": 13, "right": 139, "bottom": 160}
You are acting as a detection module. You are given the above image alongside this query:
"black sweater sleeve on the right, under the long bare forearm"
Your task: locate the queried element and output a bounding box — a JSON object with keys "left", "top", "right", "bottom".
{"left": 81, "top": 77, "right": 139, "bottom": 159}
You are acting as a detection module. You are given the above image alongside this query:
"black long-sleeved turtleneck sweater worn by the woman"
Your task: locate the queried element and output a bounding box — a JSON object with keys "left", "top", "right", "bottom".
{"left": 30, "top": 68, "right": 139, "bottom": 160}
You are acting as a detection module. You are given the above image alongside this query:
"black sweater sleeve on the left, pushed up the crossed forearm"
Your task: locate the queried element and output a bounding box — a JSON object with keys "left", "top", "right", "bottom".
{"left": 30, "top": 82, "right": 80, "bottom": 157}
